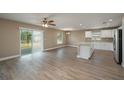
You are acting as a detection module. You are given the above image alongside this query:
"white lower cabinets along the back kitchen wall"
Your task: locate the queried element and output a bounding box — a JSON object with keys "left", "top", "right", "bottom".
{"left": 94, "top": 42, "right": 113, "bottom": 51}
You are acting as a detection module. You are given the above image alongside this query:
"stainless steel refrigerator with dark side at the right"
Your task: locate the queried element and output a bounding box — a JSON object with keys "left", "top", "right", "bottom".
{"left": 113, "top": 29, "right": 122, "bottom": 64}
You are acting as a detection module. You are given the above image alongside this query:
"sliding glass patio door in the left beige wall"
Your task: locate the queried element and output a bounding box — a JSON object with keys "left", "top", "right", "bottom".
{"left": 20, "top": 28, "right": 43, "bottom": 55}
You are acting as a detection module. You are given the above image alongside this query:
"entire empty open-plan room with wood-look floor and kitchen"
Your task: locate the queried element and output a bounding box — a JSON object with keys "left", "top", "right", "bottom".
{"left": 0, "top": 13, "right": 124, "bottom": 79}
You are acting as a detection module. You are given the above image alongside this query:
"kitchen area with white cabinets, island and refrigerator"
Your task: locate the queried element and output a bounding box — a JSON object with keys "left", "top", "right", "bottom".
{"left": 74, "top": 28, "right": 122, "bottom": 64}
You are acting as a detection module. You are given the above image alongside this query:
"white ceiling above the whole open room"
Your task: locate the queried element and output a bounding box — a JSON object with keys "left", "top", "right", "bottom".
{"left": 0, "top": 13, "right": 124, "bottom": 30}
